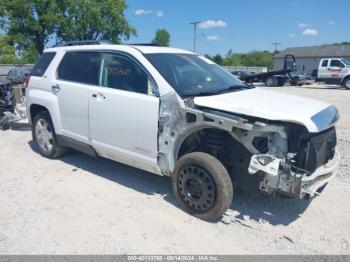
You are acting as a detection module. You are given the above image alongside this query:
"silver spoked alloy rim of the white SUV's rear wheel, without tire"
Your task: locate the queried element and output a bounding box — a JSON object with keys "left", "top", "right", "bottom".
{"left": 35, "top": 119, "right": 53, "bottom": 153}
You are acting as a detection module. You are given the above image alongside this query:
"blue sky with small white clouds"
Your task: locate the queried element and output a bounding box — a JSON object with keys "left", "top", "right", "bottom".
{"left": 124, "top": 0, "right": 350, "bottom": 55}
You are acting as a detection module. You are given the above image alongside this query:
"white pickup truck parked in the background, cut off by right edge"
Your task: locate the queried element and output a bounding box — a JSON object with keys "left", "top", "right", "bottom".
{"left": 316, "top": 58, "right": 350, "bottom": 89}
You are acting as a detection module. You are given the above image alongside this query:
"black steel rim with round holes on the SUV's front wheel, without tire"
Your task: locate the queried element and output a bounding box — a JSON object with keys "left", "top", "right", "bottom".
{"left": 177, "top": 165, "right": 216, "bottom": 213}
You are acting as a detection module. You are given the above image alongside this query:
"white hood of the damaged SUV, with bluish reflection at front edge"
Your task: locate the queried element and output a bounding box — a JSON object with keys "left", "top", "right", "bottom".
{"left": 194, "top": 88, "right": 338, "bottom": 132}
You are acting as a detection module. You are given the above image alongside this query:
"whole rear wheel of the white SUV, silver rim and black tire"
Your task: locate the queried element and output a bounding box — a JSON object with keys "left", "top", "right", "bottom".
{"left": 32, "top": 111, "right": 66, "bottom": 159}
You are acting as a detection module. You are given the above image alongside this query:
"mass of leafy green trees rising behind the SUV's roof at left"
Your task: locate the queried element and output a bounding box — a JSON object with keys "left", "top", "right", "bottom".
{"left": 0, "top": 0, "right": 136, "bottom": 54}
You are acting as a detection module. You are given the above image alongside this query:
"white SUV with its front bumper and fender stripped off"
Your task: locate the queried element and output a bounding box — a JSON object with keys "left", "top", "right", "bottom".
{"left": 27, "top": 42, "right": 339, "bottom": 220}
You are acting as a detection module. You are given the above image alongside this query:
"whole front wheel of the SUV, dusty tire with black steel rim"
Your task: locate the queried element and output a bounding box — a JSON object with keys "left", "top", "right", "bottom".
{"left": 172, "top": 152, "right": 233, "bottom": 221}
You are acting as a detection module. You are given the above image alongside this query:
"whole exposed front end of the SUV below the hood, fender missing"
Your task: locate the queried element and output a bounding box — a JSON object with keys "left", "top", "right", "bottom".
{"left": 158, "top": 91, "right": 339, "bottom": 198}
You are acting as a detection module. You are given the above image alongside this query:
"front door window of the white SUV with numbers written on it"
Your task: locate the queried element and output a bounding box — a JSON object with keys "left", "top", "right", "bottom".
{"left": 100, "top": 54, "right": 152, "bottom": 95}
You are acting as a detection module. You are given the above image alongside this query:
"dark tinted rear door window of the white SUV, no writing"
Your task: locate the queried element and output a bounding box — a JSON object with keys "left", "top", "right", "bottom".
{"left": 57, "top": 52, "right": 101, "bottom": 85}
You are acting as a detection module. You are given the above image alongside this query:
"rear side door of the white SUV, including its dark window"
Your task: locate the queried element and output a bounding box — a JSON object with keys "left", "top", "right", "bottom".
{"left": 52, "top": 51, "right": 101, "bottom": 143}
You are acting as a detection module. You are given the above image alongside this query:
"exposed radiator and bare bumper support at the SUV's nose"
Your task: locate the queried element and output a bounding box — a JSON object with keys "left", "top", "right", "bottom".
{"left": 248, "top": 127, "right": 340, "bottom": 198}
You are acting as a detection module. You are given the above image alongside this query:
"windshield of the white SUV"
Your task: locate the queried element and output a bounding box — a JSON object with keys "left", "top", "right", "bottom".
{"left": 145, "top": 54, "right": 250, "bottom": 96}
